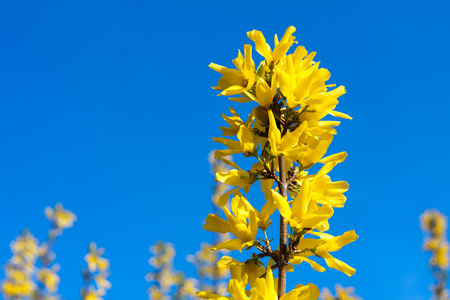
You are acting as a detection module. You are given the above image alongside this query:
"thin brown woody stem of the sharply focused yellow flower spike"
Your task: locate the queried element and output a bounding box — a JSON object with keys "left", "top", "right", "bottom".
{"left": 278, "top": 155, "right": 287, "bottom": 299}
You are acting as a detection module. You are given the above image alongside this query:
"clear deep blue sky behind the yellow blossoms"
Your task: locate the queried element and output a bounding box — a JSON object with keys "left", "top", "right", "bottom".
{"left": 0, "top": 0, "right": 450, "bottom": 300}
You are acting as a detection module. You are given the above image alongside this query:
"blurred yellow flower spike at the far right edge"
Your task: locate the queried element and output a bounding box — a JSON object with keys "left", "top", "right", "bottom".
{"left": 420, "top": 209, "right": 449, "bottom": 300}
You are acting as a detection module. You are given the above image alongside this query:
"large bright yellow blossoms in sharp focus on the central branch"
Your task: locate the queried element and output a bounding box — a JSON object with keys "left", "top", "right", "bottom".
{"left": 199, "top": 26, "right": 358, "bottom": 299}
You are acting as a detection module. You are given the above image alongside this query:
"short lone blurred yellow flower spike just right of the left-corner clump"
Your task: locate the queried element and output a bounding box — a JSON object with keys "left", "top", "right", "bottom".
{"left": 81, "top": 242, "right": 111, "bottom": 300}
